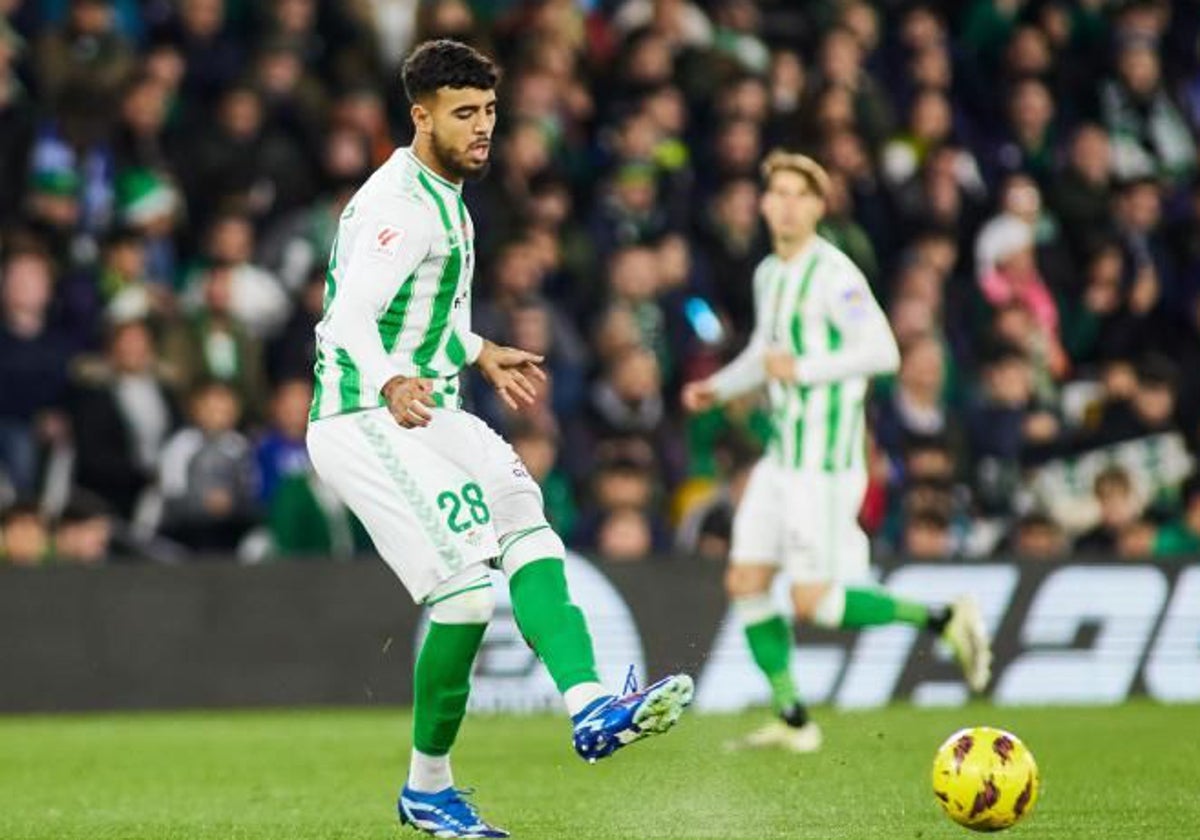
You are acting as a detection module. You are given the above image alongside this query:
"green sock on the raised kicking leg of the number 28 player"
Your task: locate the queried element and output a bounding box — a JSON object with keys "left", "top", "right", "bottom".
{"left": 509, "top": 557, "right": 600, "bottom": 691}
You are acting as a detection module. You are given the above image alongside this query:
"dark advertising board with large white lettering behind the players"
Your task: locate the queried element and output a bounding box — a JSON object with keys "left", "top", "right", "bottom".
{"left": 0, "top": 558, "right": 1200, "bottom": 712}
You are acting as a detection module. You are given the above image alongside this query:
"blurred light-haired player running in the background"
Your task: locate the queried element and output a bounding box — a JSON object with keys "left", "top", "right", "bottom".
{"left": 682, "top": 151, "right": 991, "bottom": 752}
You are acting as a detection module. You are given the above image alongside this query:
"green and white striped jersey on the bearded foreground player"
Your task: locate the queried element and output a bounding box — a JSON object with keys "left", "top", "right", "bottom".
{"left": 310, "top": 148, "right": 484, "bottom": 420}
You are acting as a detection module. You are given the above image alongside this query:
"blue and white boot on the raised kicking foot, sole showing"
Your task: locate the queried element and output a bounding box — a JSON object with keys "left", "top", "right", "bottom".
{"left": 574, "top": 667, "right": 696, "bottom": 763}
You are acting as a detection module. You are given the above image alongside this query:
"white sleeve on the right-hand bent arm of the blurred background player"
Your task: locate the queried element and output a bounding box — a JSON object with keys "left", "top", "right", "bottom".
{"left": 796, "top": 258, "right": 900, "bottom": 385}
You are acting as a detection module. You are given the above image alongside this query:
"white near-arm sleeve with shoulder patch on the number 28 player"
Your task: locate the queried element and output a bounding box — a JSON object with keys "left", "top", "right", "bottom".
{"left": 326, "top": 202, "right": 433, "bottom": 388}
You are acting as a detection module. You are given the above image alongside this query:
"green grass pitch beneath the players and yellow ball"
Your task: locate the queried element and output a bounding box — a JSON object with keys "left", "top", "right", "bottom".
{"left": 0, "top": 702, "right": 1200, "bottom": 840}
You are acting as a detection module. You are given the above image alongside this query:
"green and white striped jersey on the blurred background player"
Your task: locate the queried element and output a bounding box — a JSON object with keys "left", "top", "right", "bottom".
{"left": 713, "top": 236, "right": 899, "bottom": 473}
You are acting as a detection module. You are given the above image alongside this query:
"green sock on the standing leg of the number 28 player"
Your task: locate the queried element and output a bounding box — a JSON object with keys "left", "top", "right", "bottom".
{"left": 413, "top": 622, "right": 487, "bottom": 756}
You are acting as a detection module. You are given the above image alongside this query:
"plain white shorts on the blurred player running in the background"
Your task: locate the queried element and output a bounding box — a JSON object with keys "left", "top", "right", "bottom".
{"left": 730, "top": 458, "right": 870, "bottom": 583}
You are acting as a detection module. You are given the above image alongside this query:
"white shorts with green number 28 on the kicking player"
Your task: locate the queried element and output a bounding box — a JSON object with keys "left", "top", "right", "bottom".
{"left": 307, "top": 408, "right": 546, "bottom": 604}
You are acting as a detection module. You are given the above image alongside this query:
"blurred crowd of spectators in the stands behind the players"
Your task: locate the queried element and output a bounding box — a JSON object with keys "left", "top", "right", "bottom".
{"left": 0, "top": 0, "right": 1200, "bottom": 565}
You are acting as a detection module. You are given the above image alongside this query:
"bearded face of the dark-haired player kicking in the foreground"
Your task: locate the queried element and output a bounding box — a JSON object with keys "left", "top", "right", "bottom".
{"left": 413, "top": 88, "right": 496, "bottom": 180}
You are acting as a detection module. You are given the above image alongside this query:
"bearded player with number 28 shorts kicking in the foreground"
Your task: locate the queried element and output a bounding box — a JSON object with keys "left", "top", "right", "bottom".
{"left": 307, "top": 41, "right": 692, "bottom": 838}
